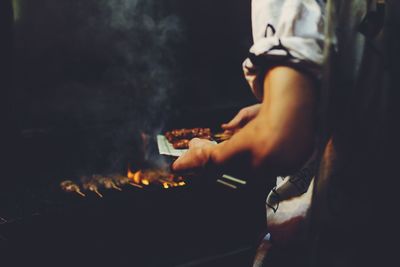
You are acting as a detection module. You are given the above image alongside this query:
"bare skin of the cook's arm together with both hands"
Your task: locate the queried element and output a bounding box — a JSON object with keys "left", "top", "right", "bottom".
{"left": 172, "top": 66, "right": 316, "bottom": 179}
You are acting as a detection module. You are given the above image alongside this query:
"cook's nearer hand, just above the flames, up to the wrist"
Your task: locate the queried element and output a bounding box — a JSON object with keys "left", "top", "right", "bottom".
{"left": 172, "top": 138, "right": 216, "bottom": 171}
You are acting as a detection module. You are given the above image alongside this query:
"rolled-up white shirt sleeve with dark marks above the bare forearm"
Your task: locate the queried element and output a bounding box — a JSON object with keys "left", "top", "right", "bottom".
{"left": 243, "top": 0, "right": 325, "bottom": 100}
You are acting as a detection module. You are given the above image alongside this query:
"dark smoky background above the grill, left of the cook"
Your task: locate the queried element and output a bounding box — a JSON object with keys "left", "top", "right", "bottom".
{"left": 0, "top": 0, "right": 254, "bottom": 180}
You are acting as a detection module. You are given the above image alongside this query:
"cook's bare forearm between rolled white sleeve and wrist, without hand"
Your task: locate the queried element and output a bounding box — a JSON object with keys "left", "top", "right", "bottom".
{"left": 208, "top": 67, "right": 315, "bottom": 177}
